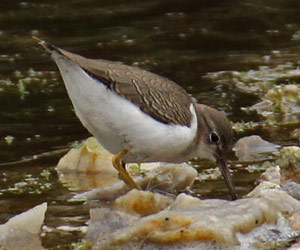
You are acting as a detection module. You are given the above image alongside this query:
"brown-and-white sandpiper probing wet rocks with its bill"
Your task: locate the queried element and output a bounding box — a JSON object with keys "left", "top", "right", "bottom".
{"left": 34, "top": 38, "right": 236, "bottom": 199}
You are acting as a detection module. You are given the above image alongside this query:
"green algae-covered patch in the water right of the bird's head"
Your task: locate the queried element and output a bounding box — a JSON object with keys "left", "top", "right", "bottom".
{"left": 205, "top": 63, "right": 300, "bottom": 125}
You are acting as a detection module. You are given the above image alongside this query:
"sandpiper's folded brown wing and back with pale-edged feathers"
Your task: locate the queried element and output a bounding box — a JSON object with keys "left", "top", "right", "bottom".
{"left": 40, "top": 42, "right": 192, "bottom": 126}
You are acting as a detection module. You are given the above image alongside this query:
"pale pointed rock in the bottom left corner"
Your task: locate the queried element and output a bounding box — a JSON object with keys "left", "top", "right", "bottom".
{"left": 0, "top": 203, "right": 47, "bottom": 250}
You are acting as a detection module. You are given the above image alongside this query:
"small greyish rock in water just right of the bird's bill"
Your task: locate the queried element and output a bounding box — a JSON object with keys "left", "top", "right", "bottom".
{"left": 233, "top": 135, "right": 280, "bottom": 161}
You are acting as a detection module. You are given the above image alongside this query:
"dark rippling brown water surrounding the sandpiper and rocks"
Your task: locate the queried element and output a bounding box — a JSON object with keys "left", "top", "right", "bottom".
{"left": 0, "top": 0, "right": 300, "bottom": 249}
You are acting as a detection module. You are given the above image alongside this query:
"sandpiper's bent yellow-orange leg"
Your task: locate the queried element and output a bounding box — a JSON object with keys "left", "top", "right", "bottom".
{"left": 112, "top": 148, "right": 141, "bottom": 190}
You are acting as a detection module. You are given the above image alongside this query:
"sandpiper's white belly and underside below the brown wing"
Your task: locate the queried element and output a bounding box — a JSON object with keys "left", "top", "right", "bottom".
{"left": 52, "top": 52, "right": 197, "bottom": 162}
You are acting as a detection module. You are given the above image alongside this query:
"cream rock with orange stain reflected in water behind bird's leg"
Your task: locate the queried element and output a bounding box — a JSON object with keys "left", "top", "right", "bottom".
{"left": 56, "top": 137, "right": 118, "bottom": 191}
